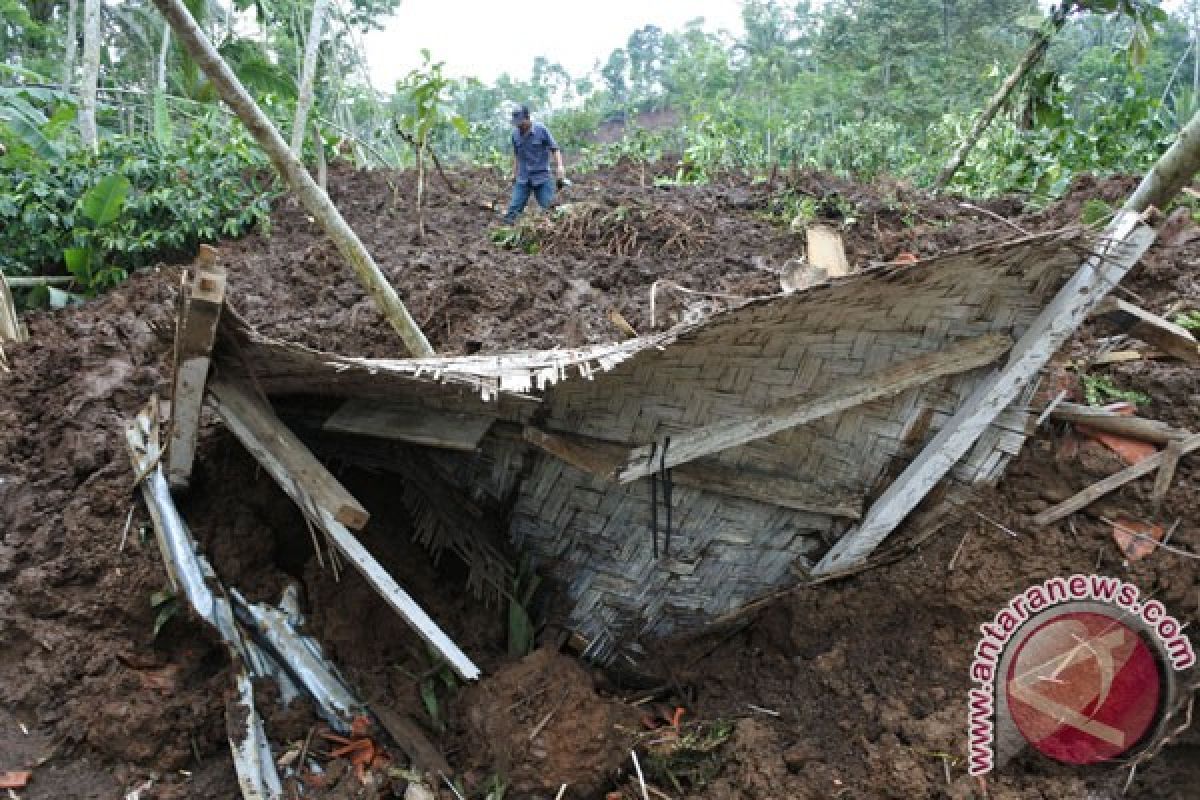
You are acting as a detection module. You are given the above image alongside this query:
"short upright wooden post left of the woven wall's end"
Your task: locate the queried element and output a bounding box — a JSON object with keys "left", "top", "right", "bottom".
{"left": 166, "top": 245, "right": 226, "bottom": 489}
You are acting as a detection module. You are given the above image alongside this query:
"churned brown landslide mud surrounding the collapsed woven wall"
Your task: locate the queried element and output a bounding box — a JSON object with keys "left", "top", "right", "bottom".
{"left": 0, "top": 168, "right": 1200, "bottom": 800}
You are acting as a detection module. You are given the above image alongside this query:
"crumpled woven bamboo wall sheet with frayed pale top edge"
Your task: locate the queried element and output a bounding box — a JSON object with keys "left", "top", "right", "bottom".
{"left": 223, "top": 227, "right": 1087, "bottom": 658}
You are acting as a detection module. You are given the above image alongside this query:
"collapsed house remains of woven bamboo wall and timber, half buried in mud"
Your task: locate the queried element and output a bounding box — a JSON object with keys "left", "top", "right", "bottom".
{"left": 184, "top": 215, "right": 1152, "bottom": 661}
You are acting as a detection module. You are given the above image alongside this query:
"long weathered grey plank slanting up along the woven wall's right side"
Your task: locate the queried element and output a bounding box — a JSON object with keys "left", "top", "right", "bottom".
{"left": 814, "top": 211, "right": 1154, "bottom": 576}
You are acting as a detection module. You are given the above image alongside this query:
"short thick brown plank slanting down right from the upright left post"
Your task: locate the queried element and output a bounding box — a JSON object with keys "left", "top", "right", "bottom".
{"left": 209, "top": 378, "right": 371, "bottom": 530}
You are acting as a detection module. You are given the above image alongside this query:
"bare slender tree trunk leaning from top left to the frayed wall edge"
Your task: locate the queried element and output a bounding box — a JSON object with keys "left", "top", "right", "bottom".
{"left": 154, "top": 0, "right": 434, "bottom": 357}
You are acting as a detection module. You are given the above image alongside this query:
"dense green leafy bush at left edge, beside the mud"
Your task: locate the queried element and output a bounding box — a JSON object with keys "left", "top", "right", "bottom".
{"left": 0, "top": 121, "right": 278, "bottom": 281}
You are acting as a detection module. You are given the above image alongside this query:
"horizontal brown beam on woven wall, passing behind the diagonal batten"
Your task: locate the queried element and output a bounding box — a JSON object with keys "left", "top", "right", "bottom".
{"left": 524, "top": 427, "right": 862, "bottom": 519}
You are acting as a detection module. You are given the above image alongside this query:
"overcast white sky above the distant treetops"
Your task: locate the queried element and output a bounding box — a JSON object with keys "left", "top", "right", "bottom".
{"left": 366, "top": 0, "right": 742, "bottom": 91}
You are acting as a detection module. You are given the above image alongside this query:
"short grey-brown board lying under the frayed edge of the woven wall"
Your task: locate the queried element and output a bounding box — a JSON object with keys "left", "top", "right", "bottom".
{"left": 322, "top": 397, "right": 494, "bottom": 452}
